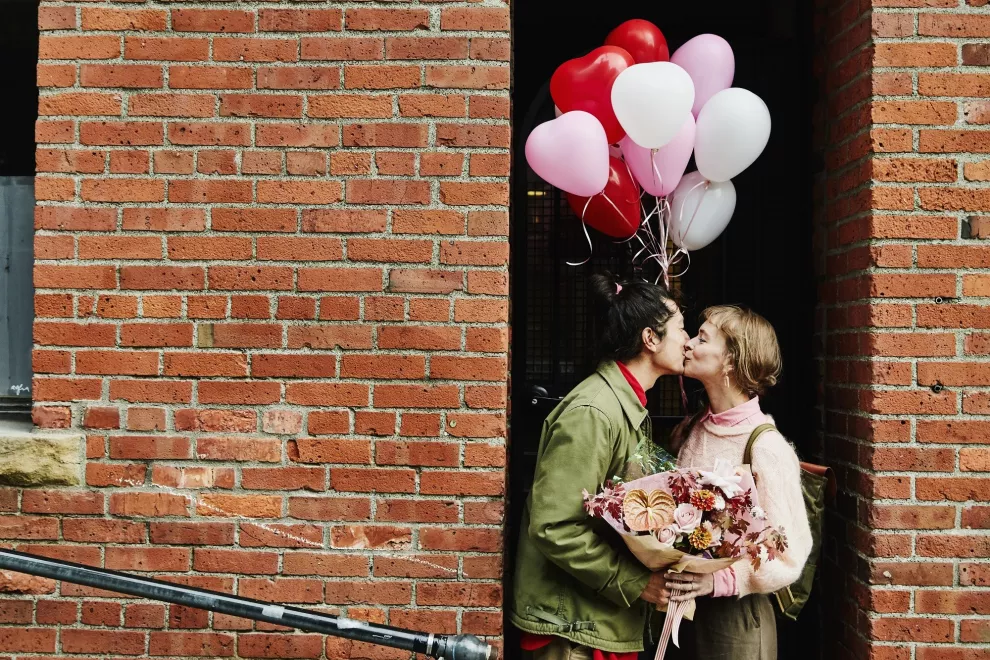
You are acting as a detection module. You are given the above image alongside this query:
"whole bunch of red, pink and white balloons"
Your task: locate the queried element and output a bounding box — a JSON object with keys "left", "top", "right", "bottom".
{"left": 526, "top": 19, "right": 770, "bottom": 282}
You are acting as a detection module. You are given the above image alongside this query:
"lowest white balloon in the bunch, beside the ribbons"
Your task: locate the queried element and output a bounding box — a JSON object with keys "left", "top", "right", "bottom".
{"left": 670, "top": 172, "right": 736, "bottom": 252}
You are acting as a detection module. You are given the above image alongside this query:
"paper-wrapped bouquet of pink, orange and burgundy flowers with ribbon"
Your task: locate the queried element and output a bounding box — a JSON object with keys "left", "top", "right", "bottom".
{"left": 583, "top": 460, "right": 787, "bottom": 660}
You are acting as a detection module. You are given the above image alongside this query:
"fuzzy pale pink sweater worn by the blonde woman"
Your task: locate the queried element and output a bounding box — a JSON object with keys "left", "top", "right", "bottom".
{"left": 677, "top": 402, "right": 812, "bottom": 596}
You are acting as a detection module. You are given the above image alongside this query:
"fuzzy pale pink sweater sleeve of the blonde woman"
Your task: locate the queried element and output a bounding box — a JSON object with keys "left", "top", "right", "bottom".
{"left": 733, "top": 431, "right": 812, "bottom": 597}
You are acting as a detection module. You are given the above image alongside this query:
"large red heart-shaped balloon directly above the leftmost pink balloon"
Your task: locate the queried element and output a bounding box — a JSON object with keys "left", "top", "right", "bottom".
{"left": 550, "top": 46, "right": 634, "bottom": 144}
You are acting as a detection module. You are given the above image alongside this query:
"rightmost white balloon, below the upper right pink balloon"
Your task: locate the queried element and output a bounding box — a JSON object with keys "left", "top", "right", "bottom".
{"left": 694, "top": 87, "right": 770, "bottom": 181}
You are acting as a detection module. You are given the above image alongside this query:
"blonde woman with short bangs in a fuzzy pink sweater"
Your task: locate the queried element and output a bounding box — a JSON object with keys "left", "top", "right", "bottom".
{"left": 664, "top": 306, "right": 812, "bottom": 660}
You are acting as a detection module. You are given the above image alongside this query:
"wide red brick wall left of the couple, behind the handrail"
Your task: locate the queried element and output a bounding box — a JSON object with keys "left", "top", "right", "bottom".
{"left": 21, "top": 0, "right": 509, "bottom": 658}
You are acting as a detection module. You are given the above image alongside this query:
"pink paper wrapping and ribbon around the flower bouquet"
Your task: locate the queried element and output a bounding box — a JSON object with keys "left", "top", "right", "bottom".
{"left": 602, "top": 468, "right": 767, "bottom": 660}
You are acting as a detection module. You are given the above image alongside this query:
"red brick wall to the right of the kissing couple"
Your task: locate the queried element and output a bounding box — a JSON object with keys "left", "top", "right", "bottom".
{"left": 816, "top": 0, "right": 990, "bottom": 660}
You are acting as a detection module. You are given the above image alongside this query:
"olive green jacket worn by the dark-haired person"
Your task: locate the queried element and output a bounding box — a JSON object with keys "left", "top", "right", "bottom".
{"left": 510, "top": 362, "right": 652, "bottom": 652}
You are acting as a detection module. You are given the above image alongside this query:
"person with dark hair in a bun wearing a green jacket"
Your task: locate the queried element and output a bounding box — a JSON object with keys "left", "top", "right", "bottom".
{"left": 510, "top": 275, "right": 688, "bottom": 660}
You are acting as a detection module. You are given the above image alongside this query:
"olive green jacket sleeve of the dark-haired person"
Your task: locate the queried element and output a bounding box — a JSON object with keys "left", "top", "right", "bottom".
{"left": 529, "top": 406, "right": 650, "bottom": 607}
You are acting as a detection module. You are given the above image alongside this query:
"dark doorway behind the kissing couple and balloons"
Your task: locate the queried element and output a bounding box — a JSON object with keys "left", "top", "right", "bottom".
{"left": 505, "top": 0, "right": 822, "bottom": 659}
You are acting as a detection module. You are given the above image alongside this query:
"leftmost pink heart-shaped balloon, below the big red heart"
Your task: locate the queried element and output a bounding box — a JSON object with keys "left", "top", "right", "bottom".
{"left": 526, "top": 110, "right": 609, "bottom": 197}
